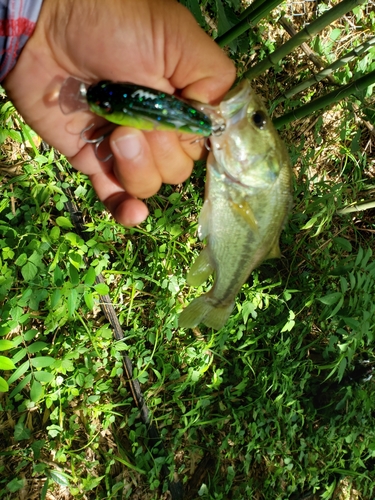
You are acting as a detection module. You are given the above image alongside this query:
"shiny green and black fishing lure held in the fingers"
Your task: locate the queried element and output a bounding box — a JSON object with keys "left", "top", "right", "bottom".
{"left": 59, "top": 77, "right": 217, "bottom": 137}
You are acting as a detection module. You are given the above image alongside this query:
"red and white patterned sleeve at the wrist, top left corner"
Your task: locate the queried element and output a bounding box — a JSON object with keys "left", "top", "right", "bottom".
{"left": 0, "top": 0, "right": 43, "bottom": 82}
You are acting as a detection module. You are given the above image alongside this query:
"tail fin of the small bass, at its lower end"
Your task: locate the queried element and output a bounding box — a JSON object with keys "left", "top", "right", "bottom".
{"left": 178, "top": 294, "right": 234, "bottom": 330}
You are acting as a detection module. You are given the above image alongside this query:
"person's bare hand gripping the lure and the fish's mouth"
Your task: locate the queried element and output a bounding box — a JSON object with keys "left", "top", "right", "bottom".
{"left": 4, "top": 0, "right": 235, "bottom": 226}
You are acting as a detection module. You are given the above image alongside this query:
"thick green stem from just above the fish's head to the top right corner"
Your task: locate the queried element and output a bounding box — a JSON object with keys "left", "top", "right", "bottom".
{"left": 245, "top": 0, "right": 366, "bottom": 80}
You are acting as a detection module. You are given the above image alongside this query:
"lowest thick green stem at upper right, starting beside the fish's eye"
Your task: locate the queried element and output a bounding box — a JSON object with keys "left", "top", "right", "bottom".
{"left": 273, "top": 70, "right": 375, "bottom": 129}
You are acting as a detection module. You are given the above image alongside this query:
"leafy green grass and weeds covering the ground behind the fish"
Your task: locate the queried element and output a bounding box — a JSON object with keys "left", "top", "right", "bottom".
{"left": 0, "top": 2, "right": 375, "bottom": 500}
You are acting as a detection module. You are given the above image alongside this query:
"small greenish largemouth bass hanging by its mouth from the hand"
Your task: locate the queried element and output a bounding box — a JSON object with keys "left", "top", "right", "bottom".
{"left": 179, "top": 79, "right": 292, "bottom": 330}
